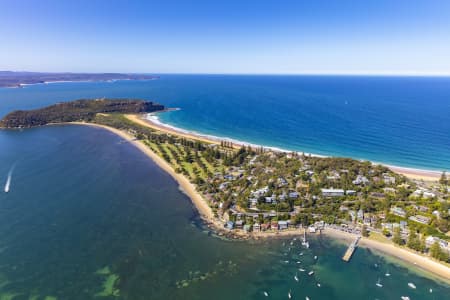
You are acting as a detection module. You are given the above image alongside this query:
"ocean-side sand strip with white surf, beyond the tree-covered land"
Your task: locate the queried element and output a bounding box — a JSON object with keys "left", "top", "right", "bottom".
{"left": 130, "top": 112, "right": 442, "bottom": 181}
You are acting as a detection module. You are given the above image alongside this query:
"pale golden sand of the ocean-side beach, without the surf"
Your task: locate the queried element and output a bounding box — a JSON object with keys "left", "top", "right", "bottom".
{"left": 127, "top": 115, "right": 441, "bottom": 181}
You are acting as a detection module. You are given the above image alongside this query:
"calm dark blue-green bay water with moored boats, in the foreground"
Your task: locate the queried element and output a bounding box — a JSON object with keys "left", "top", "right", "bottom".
{"left": 0, "top": 126, "right": 450, "bottom": 300}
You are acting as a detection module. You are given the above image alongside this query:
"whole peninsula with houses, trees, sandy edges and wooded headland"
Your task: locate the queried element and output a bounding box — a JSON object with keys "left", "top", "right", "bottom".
{"left": 0, "top": 99, "right": 450, "bottom": 281}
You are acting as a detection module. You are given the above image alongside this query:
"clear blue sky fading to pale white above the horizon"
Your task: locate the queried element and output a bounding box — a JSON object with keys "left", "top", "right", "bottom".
{"left": 0, "top": 0, "right": 450, "bottom": 74}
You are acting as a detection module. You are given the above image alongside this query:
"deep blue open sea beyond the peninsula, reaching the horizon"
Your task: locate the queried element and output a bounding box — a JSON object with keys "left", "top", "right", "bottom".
{"left": 0, "top": 75, "right": 450, "bottom": 171}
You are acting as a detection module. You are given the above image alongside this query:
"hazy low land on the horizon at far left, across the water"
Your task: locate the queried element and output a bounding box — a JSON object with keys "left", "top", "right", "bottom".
{"left": 0, "top": 71, "right": 158, "bottom": 87}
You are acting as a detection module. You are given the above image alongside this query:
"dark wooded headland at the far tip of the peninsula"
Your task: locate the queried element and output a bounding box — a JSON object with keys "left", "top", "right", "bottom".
{"left": 0, "top": 99, "right": 164, "bottom": 128}
